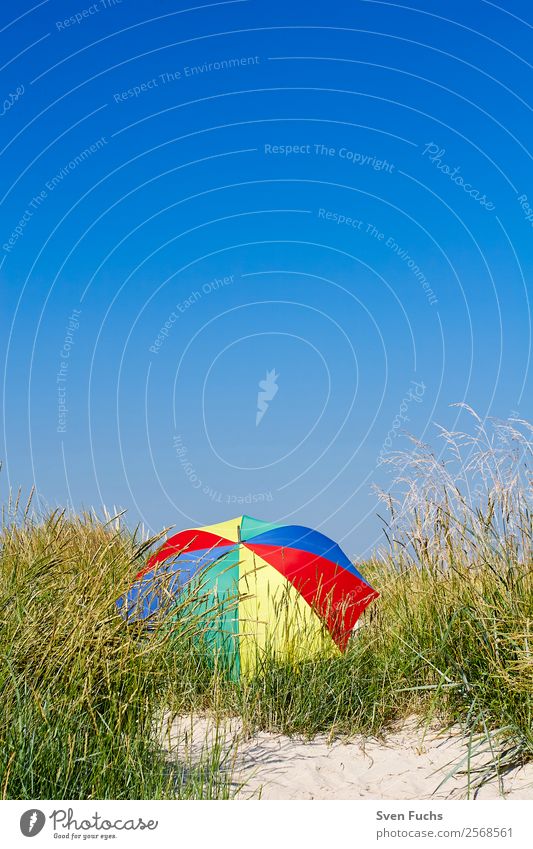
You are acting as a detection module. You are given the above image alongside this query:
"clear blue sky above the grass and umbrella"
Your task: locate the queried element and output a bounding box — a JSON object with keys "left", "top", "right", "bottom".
{"left": 0, "top": 0, "right": 533, "bottom": 556}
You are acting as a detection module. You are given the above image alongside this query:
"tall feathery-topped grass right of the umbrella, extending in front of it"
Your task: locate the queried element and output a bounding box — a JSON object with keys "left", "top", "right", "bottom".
{"left": 164, "top": 410, "right": 533, "bottom": 784}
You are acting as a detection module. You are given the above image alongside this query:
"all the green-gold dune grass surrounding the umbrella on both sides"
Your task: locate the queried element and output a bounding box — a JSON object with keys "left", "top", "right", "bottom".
{"left": 0, "top": 410, "right": 533, "bottom": 798}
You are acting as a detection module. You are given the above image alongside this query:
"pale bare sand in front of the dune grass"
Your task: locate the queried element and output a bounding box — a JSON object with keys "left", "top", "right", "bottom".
{"left": 161, "top": 717, "right": 533, "bottom": 800}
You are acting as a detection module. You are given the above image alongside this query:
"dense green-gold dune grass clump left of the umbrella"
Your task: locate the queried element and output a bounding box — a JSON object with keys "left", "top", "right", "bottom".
{"left": 0, "top": 500, "right": 233, "bottom": 799}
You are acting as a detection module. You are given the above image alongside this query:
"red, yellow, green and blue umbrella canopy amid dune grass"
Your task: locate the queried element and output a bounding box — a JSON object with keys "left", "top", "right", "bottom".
{"left": 118, "top": 516, "right": 379, "bottom": 672}
